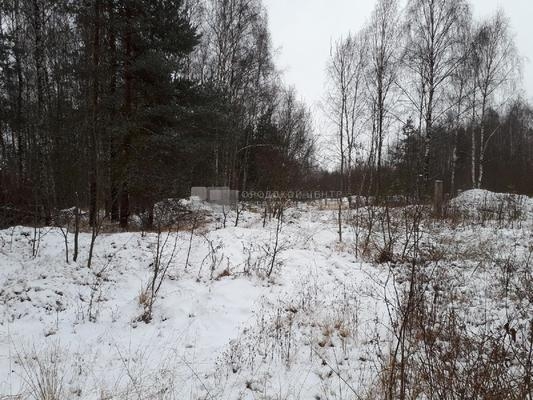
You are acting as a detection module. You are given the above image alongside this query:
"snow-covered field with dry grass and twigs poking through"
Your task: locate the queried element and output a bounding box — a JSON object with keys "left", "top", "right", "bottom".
{"left": 0, "top": 193, "right": 533, "bottom": 399}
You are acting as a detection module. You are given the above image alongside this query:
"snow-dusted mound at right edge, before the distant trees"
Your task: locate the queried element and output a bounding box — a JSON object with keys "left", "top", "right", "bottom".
{"left": 450, "top": 189, "right": 533, "bottom": 218}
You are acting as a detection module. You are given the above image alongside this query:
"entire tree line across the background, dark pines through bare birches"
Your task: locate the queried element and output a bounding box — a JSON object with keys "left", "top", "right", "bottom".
{"left": 0, "top": 0, "right": 533, "bottom": 228}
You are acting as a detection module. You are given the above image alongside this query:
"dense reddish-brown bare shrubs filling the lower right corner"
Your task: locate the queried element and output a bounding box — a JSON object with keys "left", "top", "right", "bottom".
{"left": 374, "top": 244, "right": 533, "bottom": 400}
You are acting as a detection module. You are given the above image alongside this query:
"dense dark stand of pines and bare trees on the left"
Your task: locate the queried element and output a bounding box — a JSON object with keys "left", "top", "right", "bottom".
{"left": 0, "top": 0, "right": 315, "bottom": 228}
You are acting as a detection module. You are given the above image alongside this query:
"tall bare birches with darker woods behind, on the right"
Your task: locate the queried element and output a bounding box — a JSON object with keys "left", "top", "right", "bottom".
{"left": 323, "top": 0, "right": 533, "bottom": 196}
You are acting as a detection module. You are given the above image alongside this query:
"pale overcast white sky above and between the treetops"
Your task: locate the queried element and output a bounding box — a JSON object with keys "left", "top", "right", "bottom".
{"left": 264, "top": 0, "right": 533, "bottom": 113}
